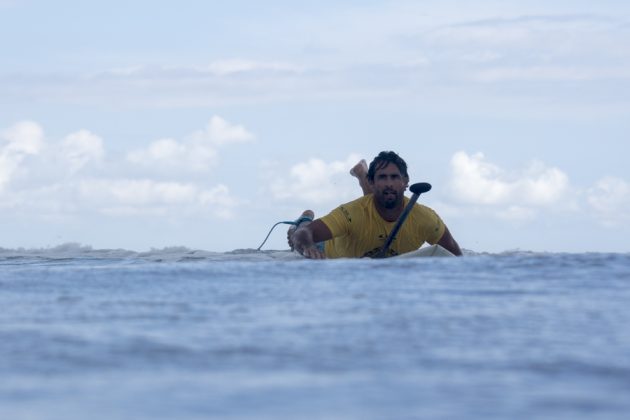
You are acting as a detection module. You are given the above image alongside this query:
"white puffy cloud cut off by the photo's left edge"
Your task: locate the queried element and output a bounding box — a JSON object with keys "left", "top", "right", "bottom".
{"left": 0, "top": 121, "right": 44, "bottom": 193}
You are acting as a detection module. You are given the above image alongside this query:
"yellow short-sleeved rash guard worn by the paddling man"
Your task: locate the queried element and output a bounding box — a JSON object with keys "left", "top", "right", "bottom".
{"left": 320, "top": 194, "right": 445, "bottom": 258}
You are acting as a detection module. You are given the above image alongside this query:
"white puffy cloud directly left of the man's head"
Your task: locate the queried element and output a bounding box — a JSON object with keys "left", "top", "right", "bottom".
{"left": 271, "top": 154, "right": 360, "bottom": 204}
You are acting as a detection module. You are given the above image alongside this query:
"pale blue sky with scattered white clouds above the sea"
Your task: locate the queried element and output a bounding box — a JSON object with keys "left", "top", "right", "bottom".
{"left": 0, "top": 0, "right": 630, "bottom": 252}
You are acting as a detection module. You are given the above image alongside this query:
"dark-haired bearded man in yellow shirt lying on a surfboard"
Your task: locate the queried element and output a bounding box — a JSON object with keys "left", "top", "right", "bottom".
{"left": 289, "top": 152, "right": 462, "bottom": 259}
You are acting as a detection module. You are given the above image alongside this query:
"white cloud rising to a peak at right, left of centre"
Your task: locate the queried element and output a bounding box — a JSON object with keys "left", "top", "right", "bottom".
{"left": 127, "top": 115, "right": 254, "bottom": 171}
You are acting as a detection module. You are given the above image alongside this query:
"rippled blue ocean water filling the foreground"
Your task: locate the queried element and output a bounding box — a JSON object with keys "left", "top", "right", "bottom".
{"left": 0, "top": 244, "right": 630, "bottom": 420}
